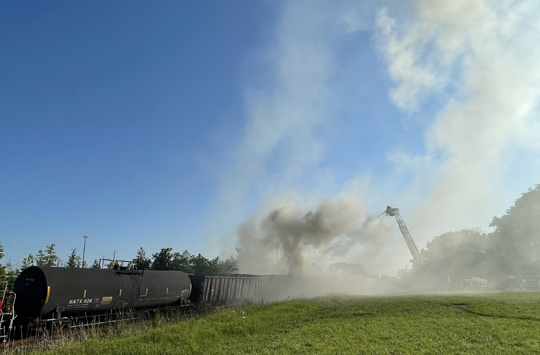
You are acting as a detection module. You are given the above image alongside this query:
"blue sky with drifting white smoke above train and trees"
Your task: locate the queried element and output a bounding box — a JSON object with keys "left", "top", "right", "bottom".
{"left": 0, "top": 0, "right": 540, "bottom": 273}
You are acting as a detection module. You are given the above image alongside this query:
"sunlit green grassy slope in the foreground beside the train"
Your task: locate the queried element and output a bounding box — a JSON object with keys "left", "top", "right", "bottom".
{"left": 24, "top": 292, "right": 540, "bottom": 355}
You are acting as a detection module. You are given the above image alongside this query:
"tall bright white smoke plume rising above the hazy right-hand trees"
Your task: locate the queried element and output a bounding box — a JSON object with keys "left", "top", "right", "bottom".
{"left": 376, "top": 0, "right": 540, "bottom": 241}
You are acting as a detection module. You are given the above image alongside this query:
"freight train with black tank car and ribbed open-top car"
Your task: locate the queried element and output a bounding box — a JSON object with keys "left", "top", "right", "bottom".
{"left": 0, "top": 266, "right": 309, "bottom": 335}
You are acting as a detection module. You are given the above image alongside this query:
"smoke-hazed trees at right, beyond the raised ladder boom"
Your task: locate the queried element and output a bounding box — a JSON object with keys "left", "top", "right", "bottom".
{"left": 410, "top": 185, "right": 540, "bottom": 286}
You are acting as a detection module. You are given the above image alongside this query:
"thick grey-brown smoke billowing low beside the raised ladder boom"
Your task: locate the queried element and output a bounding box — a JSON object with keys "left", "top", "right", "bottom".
{"left": 237, "top": 198, "right": 393, "bottom": 275}
